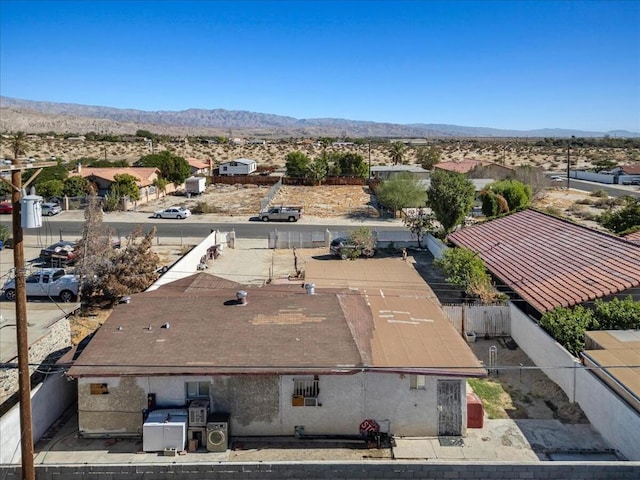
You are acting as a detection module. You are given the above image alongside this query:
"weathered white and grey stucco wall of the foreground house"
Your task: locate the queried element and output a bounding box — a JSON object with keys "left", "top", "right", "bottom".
{"left": 78, "top": 372, "right": 466, "bottom": 436}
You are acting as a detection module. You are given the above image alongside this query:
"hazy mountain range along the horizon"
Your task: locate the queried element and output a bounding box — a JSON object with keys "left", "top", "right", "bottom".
{"left": 0, "top": 96, "right": 640, "bottom": 138}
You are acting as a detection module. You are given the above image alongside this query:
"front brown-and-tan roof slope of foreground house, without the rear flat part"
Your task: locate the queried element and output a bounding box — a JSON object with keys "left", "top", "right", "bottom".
{"left": 69, "top": 266, "right": 485, "bottom": 377}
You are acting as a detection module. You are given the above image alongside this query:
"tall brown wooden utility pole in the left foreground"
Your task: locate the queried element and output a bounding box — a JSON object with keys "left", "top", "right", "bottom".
{"left": 11, "top": 162, "right": 36, "bottom": 480}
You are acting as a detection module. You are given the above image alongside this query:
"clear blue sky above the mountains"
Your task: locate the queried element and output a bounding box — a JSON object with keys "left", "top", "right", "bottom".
{"left": 0, "top": 0, "right": 640, "bottom": 132}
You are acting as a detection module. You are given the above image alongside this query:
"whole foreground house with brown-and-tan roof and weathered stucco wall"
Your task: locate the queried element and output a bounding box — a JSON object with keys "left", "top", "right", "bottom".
{"left": 68, "top": 258, "right": 486, "bottom": 436}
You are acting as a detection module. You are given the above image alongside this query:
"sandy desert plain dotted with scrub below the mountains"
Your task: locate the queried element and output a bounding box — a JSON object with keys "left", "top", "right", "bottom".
{"left": 0, "top": 135, "right": 640, "bottom": 172}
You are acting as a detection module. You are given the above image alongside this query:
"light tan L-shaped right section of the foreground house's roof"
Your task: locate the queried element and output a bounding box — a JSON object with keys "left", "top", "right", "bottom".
{"left": 305, "top": 258, "right": 479, "bottom": 376}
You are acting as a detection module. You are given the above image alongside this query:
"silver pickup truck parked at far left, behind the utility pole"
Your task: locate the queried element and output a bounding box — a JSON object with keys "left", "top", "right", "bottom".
{"left": 2, "top": 268, "right": 78, "bottom": 302}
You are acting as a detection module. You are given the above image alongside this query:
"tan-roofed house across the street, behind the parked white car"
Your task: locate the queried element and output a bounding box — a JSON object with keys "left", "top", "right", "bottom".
{"left": 71, "top": 165, "right": 170, "bottom": 204}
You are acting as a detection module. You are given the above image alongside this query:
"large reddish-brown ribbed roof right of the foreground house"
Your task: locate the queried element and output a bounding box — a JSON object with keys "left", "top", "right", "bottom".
{"left": 449, "top": 210, "right": 640, "bottom": 313}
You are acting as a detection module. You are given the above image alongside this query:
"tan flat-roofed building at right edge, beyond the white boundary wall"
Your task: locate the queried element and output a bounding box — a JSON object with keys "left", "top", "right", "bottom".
{"left": 581, "top": 330, "right": 640, "bottom": 414}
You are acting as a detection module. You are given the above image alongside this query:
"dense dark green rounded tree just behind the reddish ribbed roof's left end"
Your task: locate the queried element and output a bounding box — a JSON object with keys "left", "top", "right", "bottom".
{"left": 427, "top": 169, "right": 475, "bottom": 235}
